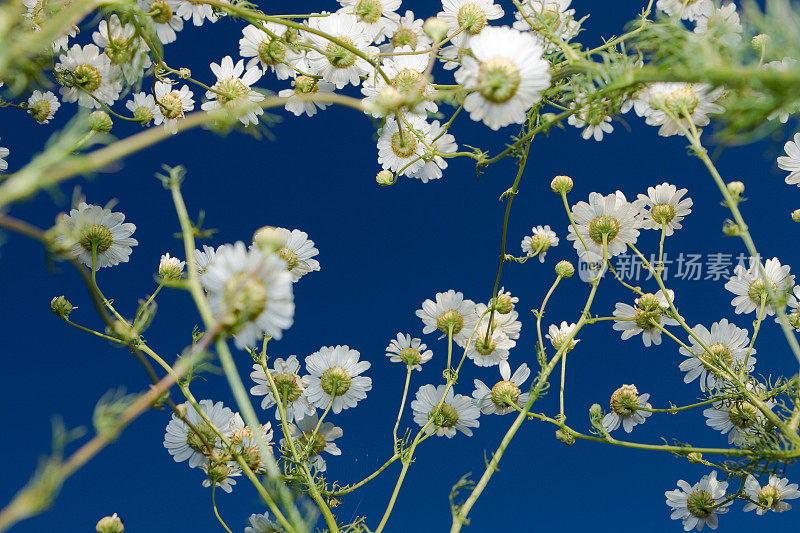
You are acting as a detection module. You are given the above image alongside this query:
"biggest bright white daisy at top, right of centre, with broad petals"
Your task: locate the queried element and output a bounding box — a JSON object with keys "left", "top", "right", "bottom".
{"left": 455, "top": 27, "right": 550, "bottom": 130}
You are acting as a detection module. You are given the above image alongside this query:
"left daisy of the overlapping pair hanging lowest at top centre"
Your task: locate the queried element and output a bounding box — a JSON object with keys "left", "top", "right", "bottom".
{"left": 378, "top": 115, "right": 431, "bottom": 176}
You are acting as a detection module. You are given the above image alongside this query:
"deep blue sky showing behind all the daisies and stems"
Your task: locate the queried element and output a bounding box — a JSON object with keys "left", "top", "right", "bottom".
{"left": 0, "top": 0, "right": 800, "bottom": 533}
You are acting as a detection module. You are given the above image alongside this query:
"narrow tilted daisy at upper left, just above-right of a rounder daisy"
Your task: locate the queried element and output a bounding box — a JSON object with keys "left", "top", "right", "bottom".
{"left": 92, "top": 14, "right": 153, "bottom": 84}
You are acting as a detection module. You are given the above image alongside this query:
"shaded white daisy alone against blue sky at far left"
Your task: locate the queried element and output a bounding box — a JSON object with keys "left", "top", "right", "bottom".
{"left": 56, "top": 202, "right": 139, "bottom": 269}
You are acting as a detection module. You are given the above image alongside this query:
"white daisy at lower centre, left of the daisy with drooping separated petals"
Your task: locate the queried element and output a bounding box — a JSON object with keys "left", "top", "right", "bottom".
{"left": 411, "top": 385, "right": 481, "bottom": 439}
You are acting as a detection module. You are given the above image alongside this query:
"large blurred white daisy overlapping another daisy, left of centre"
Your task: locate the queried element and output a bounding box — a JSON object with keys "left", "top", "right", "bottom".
{"left": 201, "top": 241, "right": 294, "bottom": 349}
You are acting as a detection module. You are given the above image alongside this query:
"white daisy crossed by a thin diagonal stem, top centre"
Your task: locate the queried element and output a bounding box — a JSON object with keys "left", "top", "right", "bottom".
{"left": 307, "top": 13, "right": 378, "bottom": 89}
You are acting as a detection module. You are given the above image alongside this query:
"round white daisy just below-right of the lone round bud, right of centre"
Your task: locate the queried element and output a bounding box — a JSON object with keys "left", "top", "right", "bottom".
{"left": 567, "top": 191, "right": 639, "bottom": 258}
